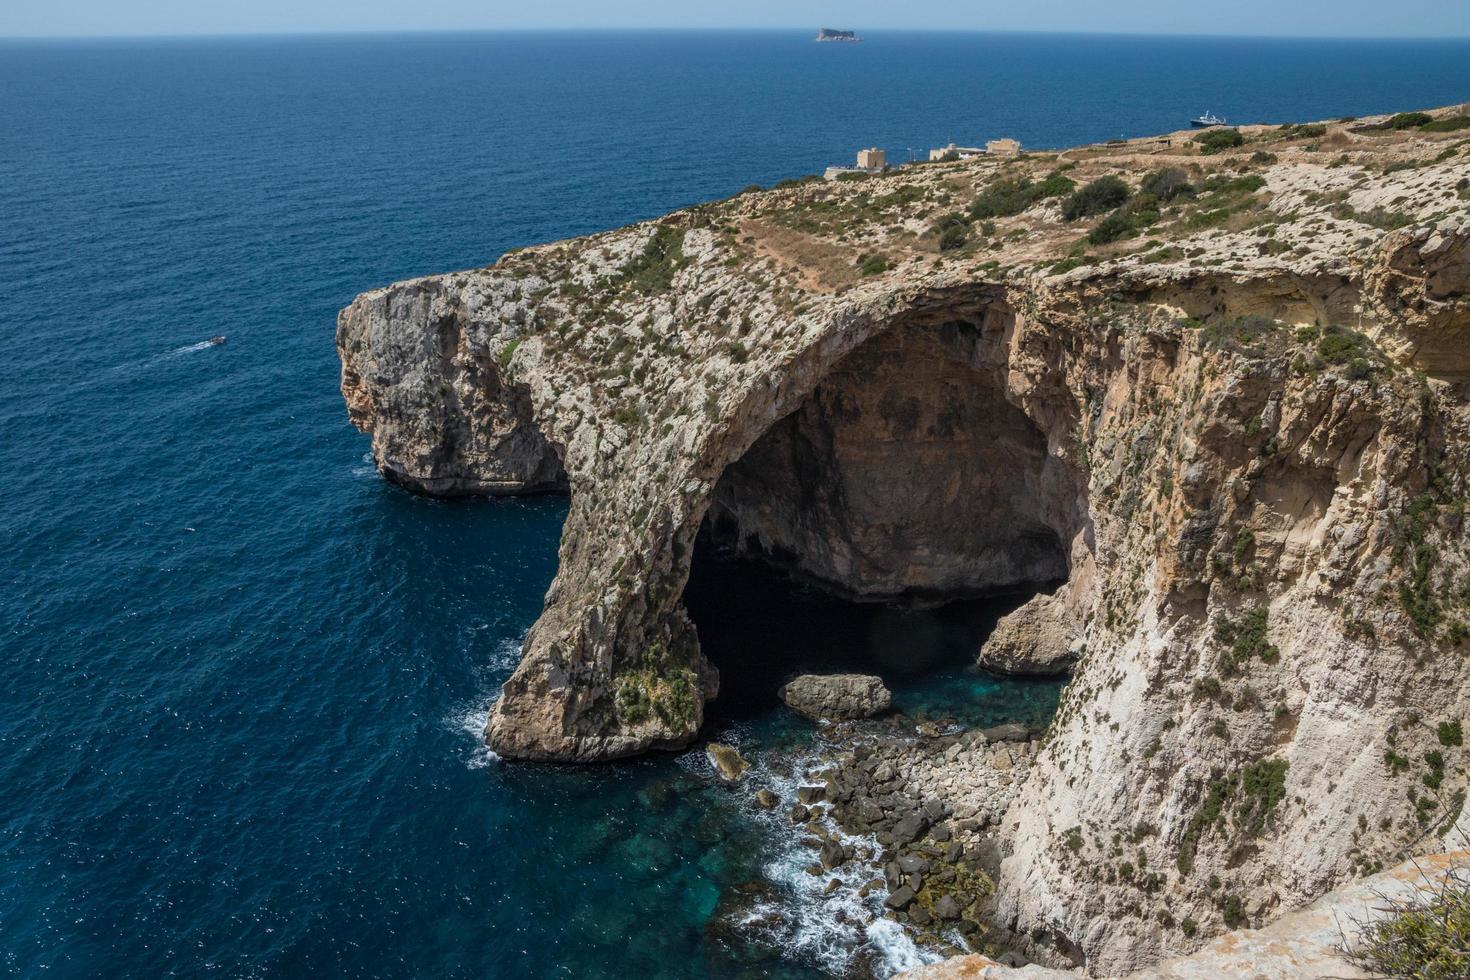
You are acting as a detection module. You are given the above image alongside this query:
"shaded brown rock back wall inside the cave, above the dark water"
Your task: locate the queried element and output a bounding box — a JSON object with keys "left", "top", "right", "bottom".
{"left": 707, "top": 320, "right": 1085, "bottom": 599}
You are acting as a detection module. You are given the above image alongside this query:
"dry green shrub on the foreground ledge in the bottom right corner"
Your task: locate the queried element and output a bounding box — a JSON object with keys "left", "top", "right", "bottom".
{"left": 1347, "top": 868, "right": 1470, "bottom": 980}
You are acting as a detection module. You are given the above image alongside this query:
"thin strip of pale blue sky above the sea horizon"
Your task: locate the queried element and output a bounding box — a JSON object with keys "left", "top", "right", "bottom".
{"left": 0, "top": 0, "right": 1470, "bottom": 37}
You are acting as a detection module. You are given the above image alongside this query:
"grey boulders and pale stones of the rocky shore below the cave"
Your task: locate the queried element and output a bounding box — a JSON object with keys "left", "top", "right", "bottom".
{"left": 709, "top": 690, "right": 1058, "bottom": 976}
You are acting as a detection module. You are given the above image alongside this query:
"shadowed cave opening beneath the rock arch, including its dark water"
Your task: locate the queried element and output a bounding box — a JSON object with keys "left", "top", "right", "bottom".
{"left": 685, "top": 322, "right": 1079, "bottom": 720}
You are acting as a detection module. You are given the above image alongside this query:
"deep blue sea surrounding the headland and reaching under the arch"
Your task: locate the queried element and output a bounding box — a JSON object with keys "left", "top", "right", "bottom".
{"left": 0, "top": 25, "right": 1470, "bottom": 980}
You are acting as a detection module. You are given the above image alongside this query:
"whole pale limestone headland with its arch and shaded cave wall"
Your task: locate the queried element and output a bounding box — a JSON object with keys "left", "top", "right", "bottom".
{"left": 338, "top": 109, "right": 1470, "bottom": 973}
